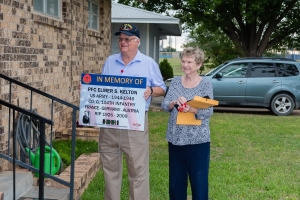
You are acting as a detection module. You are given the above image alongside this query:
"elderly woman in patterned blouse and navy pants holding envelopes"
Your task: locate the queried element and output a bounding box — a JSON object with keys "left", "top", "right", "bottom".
{"left": 161, "top": 47, "right": 213, "bottom": 200}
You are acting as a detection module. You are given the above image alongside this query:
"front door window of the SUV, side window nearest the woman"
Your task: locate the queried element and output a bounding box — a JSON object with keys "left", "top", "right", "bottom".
{"left": 220, "top": 63, "right": 248, "bottom": 78}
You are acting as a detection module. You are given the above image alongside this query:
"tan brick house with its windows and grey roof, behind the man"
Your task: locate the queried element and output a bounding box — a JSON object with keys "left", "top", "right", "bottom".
{"left": 0, "top": 0, "right": 181, "bottom": 172}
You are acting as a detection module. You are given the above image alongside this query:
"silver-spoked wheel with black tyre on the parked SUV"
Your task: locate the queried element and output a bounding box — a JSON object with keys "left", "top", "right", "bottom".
{"left": 271, "top": 94, "right": 295, "bottom": 116}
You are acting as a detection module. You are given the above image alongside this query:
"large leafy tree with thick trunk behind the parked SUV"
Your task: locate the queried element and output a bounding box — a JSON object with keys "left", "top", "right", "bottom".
{"left": 119, "top": 0, "right": 300, "bottom": 57}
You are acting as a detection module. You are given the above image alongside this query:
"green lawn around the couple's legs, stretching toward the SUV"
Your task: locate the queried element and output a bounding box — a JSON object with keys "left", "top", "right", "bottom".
{"left": 82, "top": 111, "right": 300, "bottom": 200}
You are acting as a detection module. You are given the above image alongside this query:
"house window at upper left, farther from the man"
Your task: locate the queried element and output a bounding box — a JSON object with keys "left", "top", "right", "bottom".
{"left": 33, "top": 0, "right": 61, "bottom": 18}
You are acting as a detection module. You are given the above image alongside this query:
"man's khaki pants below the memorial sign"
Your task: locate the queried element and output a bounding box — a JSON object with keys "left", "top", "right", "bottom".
{"left": 98, "top": 113, "right": 150, "bottom": 200}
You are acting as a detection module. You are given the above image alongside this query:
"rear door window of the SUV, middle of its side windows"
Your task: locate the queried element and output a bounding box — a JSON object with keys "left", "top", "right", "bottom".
{"left": 250, "top": 63, "right": 276, "bottom": 77}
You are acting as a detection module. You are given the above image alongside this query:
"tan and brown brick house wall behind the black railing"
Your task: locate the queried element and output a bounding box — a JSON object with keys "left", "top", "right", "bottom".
{"left": 0, "top": 0, "right": 111, "bottom": 170}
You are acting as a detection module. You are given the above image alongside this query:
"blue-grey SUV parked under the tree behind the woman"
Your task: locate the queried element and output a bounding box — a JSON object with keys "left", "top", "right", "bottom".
{"left": 167, "top": 58, "right": 300, "bottom": 116}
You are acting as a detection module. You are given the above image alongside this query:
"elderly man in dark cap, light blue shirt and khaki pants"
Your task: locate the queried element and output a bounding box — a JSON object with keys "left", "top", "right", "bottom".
{"left": 99, "top": 23, "right": 166, "bottom": 200}
